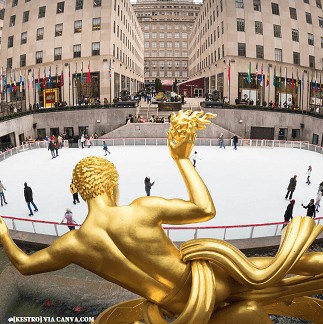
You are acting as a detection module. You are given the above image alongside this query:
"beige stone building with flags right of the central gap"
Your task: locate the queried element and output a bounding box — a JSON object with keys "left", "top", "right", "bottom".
{"left": 189, "top": 0, "right": 323, "bottom": 110}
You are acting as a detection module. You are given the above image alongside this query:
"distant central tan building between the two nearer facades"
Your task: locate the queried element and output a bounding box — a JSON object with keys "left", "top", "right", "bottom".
{"left": 133, "top": 0, "right": 201, "bottom": 86}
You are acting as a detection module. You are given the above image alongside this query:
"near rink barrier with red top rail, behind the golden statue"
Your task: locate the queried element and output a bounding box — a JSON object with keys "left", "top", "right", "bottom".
{"left": 2, "top": 216, "right": 323, "bottom": 241}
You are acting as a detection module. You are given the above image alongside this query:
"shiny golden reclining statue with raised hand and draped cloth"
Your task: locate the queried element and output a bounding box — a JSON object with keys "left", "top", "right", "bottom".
{"left": 0, "top": 111, "right": 323, "bottom": 324}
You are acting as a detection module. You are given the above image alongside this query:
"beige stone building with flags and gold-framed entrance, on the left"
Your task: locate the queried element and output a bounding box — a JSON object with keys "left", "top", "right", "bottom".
{"left": 0, "top": 0, "right": 144, "bottom": 107}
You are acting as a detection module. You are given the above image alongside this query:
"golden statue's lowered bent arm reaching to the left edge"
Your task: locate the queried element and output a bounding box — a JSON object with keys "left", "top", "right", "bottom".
{"left": 0, "top": 217, "right": 71, "bottom": 275}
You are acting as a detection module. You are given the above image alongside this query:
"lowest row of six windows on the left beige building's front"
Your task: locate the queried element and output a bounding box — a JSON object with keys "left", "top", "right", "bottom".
{"left": 7, "top": 42, "right": 100, "bottom": 69}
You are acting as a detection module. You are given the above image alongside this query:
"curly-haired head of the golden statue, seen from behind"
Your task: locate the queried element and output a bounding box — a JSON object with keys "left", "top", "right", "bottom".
{"left": 73, "top": 156, "right": 119, "bottom": 201}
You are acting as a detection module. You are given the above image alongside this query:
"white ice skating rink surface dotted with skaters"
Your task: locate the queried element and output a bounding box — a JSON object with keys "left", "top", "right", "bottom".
{"left": 0, "top": 146, "right": 323, "bottom": 234}
